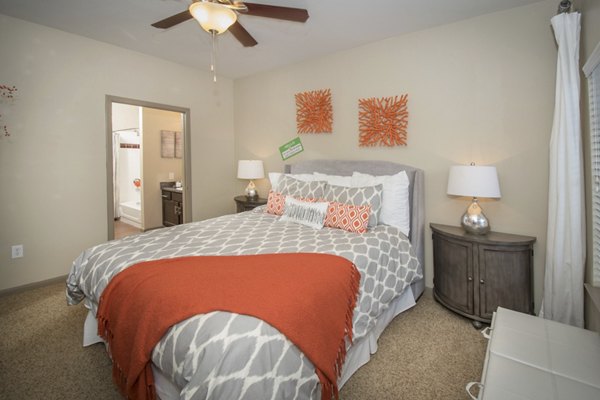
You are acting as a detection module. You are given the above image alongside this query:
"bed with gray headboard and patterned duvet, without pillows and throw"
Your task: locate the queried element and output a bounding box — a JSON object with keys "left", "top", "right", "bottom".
{"left": 67, "top": 160, "right": 424, "bottom": 400}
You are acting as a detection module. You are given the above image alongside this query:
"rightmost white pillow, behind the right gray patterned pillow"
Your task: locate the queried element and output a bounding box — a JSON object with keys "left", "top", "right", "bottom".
{"left": 352, "top": 171, "right": 410, "bottom": 236}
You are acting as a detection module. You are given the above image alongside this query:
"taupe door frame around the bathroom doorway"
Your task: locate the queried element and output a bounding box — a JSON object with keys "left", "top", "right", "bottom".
{"left": 105, "top": 94, "right": 192, "bottom": 240}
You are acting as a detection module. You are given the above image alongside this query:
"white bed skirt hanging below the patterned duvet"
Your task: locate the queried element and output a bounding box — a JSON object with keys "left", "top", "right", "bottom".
{"left": 83, "top": 286, "right": 423, "bottom": 400}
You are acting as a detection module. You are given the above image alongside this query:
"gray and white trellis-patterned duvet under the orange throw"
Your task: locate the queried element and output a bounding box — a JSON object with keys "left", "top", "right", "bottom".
{"left": 67, "top": 207, "right": 422, "bottom": 399}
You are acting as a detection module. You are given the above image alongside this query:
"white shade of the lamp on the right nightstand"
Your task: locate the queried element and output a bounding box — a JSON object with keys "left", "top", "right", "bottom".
{"left": 447, "top": 165, "right": 500, "bottom": 198}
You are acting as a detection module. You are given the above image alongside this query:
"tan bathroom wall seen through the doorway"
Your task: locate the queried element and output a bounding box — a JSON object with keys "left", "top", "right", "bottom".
{"left": 142, "top": 107, "right": 184, "bottom": 229}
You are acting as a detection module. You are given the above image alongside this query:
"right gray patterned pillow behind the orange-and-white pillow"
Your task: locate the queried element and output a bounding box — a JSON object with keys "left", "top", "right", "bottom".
{"left": 325, "top": 185, "right": 383, "bottom": 228}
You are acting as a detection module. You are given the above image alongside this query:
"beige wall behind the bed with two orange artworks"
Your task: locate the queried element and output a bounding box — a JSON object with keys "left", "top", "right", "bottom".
{"left": 234, "top": 0, "right": 556, "bottom": 309}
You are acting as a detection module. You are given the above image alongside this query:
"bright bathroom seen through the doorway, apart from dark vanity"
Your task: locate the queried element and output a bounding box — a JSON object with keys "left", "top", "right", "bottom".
{"left": 112, "top": 102, "right": 184, "bottom": 238}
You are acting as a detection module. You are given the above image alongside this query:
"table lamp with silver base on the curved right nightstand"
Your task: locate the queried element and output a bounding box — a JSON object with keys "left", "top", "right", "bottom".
{"left": 447, "top": 164, "right": 500, "bottom": 235}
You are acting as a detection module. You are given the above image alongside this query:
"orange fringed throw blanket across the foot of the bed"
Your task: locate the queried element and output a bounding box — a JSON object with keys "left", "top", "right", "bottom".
{"left": 96, "top": 253, "right": 360, "bottom": 400}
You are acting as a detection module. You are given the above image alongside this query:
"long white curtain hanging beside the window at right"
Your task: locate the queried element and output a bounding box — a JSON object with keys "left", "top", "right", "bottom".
{"left": 540, "top": 13, "right": 585, "bottom": 327}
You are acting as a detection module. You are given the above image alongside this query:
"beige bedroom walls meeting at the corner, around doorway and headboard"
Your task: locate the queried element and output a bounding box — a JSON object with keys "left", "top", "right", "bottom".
{"left": 0, "top": 0, "right": 600, "bottom": 308}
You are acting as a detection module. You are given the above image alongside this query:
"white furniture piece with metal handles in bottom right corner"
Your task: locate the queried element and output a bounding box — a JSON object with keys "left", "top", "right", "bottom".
{"left": 467, "top": 307, "right": 600, "bottom": 400}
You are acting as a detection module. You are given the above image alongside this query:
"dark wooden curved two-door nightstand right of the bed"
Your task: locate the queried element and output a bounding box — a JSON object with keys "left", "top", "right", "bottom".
{"left": 429, "top": 224, "right": 536, "bottom": 328}
